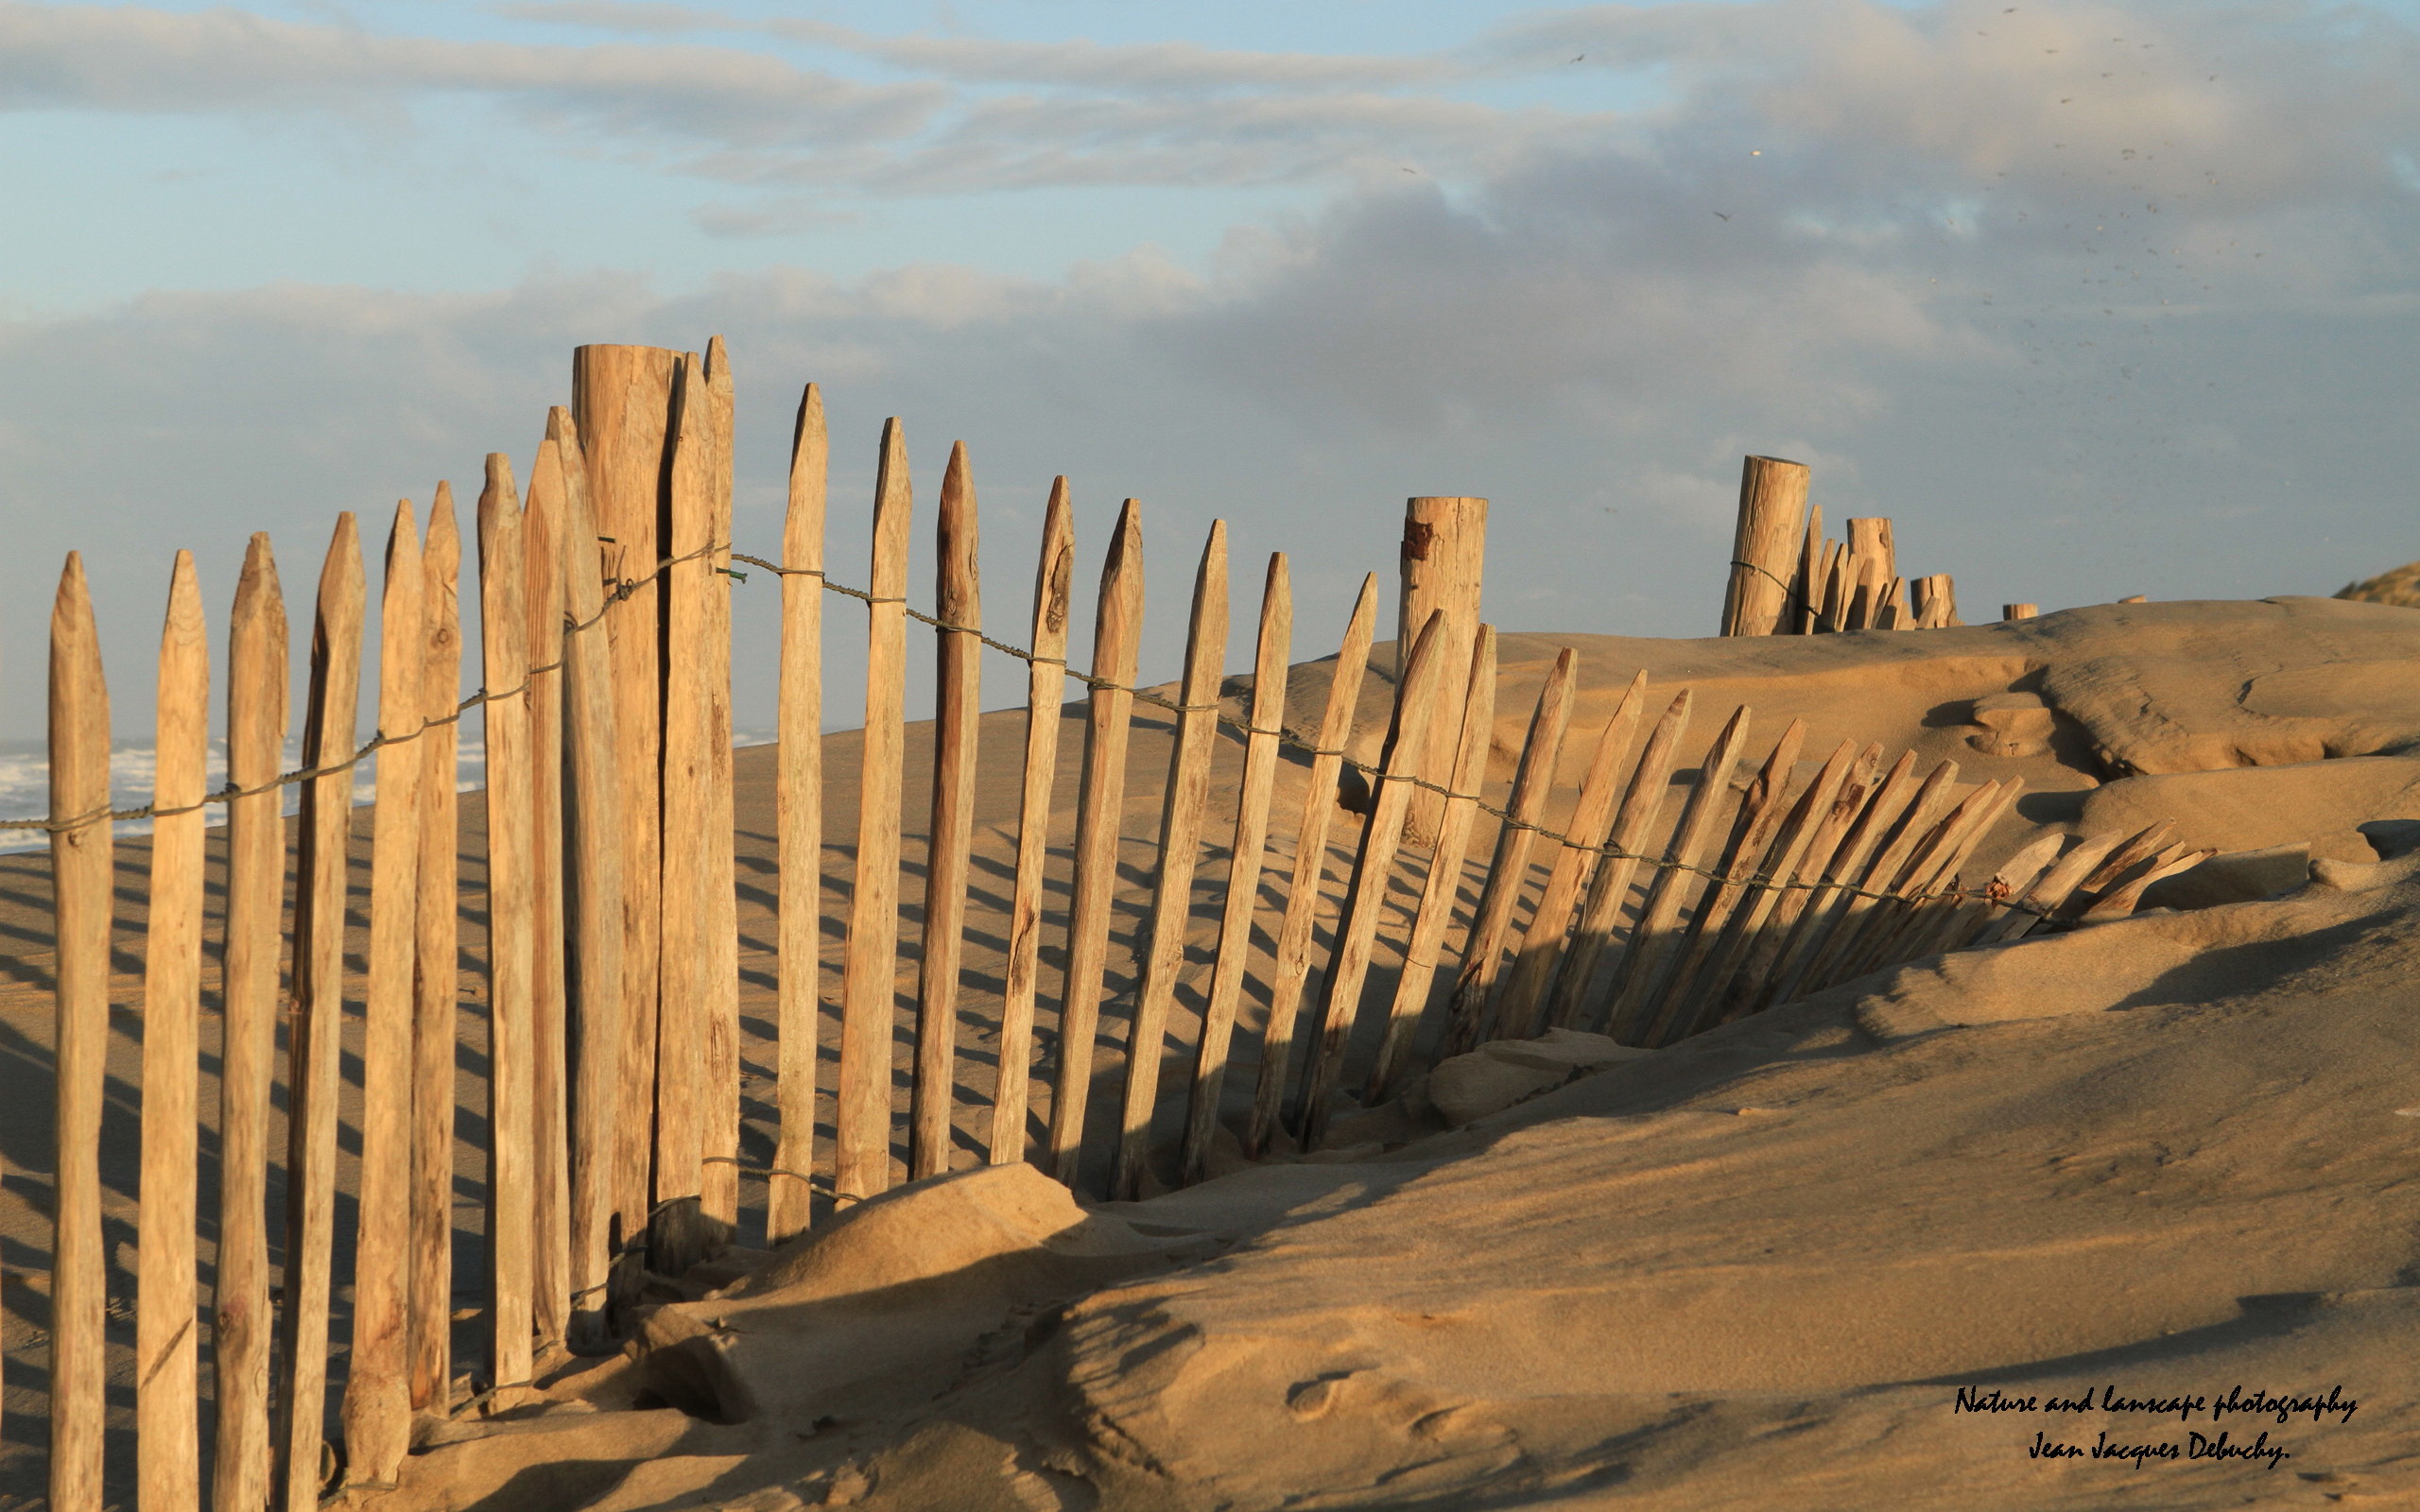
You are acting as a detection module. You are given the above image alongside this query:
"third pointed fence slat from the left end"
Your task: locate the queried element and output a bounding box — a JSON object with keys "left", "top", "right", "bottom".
{"left": 211, "top": 535, "right": 286, "bottom": 1512}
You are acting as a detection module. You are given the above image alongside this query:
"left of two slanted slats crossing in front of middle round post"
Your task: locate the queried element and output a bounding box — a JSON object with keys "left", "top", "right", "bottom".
{"left": 1302, "top": 610, "right": 1442, "bottom": 1149}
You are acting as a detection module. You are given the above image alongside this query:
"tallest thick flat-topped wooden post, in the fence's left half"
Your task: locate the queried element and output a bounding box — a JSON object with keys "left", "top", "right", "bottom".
{"left": 571, "top": 346, "right": 680, "bottom": 1244}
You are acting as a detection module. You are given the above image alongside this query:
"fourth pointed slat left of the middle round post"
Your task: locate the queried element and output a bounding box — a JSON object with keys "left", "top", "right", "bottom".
{"left": 1050, "top": 498, "right": 1142, "bottom": 1185}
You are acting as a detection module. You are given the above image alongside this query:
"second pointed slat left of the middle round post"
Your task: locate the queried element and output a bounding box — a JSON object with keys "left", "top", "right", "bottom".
{"left": 1176, "top": 552, "right": 1297, "bottom": 1185}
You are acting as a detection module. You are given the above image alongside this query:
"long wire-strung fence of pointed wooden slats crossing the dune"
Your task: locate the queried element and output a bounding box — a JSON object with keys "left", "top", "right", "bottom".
{"left": 23, "top": 338, "right": 2192, "bottom": 1512}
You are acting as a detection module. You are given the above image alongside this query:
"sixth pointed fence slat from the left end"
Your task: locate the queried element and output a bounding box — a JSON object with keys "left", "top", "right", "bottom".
{"left": 406, "top": 481, "right": 462, "bottom": 1413}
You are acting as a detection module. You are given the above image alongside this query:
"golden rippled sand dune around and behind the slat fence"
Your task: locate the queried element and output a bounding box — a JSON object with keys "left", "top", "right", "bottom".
{"left": 0, "top": 600, "right": 2420, "bottom": 1512}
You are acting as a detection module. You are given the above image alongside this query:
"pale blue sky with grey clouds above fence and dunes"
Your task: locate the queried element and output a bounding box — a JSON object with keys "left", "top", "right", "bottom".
{"left": 0, "top": 0, "right": 2420, "bottom": 738}
